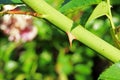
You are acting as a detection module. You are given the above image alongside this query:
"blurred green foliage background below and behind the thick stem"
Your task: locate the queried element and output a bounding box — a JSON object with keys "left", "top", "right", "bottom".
{"left": 0, "top": 0, "right": 120, "bottom": 80}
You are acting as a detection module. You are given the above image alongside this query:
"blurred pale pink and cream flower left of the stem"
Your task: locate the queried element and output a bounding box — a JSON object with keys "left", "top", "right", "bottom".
{"left": 0, "top": 7, "right": 37, "bottom": 42}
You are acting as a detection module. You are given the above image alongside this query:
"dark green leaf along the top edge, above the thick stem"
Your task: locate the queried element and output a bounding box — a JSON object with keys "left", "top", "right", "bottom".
{"left": 60, "top": 0, "right": 101, "bottom": 13}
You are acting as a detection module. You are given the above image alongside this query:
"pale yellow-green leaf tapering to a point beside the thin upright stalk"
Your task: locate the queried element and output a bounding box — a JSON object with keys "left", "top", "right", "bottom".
{"left": 86, "top": 1, "right": 109, "bottom": 24}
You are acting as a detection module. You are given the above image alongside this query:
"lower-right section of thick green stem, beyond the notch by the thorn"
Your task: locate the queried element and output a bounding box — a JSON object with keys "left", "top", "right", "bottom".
{"left": 72, "top": 25, "right": 120, "bottom": 62}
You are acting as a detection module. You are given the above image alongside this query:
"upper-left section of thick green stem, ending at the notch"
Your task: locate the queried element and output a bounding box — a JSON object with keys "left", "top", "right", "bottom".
{"left": 22, "top": 0, "right": 73, "bottom": 32}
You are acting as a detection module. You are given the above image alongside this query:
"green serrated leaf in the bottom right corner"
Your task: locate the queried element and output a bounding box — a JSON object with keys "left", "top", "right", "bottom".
{"left": 98, "top": 62, "right": 120, "bottom": 80}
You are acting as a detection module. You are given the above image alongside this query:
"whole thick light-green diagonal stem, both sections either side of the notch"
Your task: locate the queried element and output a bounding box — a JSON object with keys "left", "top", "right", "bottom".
{"left": 22, "top": 0, "right": 120, "bottom": 62}
